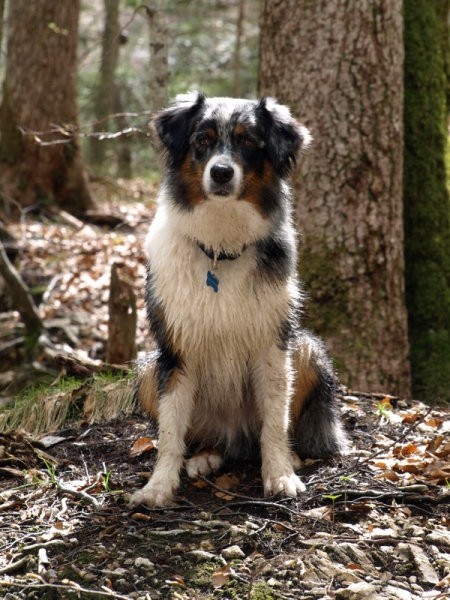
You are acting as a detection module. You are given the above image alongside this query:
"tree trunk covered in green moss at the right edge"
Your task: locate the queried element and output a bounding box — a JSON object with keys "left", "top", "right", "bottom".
{"left": 404, "top": 0, "right": 450, "bottom": 401}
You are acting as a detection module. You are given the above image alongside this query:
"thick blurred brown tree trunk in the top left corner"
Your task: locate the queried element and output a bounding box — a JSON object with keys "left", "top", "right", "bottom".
{"left": 0, "top": 0, "right": 93, "bottom": 213}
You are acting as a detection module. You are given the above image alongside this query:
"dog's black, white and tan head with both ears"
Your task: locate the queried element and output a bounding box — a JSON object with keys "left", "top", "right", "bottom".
{"left": 153, "top": 92, "right": 311, "bottom": 216}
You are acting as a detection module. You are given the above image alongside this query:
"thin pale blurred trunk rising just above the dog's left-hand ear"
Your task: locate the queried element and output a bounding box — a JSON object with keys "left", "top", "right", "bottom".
{"left": 145, "top": 0, "right": 169, "bottom": 110}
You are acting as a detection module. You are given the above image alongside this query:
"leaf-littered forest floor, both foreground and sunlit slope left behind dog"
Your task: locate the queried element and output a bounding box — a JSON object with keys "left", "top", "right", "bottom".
{"left": 0, "top": 182, "right": 450, "bottom": 600}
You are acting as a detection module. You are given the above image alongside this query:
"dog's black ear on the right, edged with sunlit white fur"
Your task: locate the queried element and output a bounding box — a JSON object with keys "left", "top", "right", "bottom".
{"left": 256, "top": 98, "right": 312, "bottom": 177}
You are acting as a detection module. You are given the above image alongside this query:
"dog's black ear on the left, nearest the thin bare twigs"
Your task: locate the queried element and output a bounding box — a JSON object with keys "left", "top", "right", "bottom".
{"left": 152, "top": 92, "right": 205, "bottom": 160}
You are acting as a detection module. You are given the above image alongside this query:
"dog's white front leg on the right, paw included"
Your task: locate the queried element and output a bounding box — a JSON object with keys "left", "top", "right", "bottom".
{"left": 253, "top": 346, "right": 305, "bottom": 496}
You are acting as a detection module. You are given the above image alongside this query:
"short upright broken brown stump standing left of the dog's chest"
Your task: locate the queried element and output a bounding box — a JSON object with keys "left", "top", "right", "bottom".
{"left": 106, "top": 263, "right": 137, "bottom": 365}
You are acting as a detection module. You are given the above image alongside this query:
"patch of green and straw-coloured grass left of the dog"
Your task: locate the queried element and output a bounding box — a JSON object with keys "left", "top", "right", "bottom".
{"left": 0, "top": 373, "right": 136, "bottom": 434}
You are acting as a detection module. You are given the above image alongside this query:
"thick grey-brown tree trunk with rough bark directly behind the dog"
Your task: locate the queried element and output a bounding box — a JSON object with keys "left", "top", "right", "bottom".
{"left": 260, "top": 0, "right": 410, "bottom": 395}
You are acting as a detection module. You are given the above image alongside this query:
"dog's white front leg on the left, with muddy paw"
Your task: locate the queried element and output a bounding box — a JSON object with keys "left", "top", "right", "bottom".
{"left": 130, "top": 372, "right": 194, "bottom": 506}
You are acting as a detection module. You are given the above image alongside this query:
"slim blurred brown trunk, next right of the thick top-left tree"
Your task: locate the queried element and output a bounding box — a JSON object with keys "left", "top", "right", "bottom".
{"left": 89, "top": 0, "right": 120, "bottom": 166}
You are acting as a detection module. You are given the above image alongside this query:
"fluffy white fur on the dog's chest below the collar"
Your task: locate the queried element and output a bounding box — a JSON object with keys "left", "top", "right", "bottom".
{"left": 146, "top": 197, "right": 295, "bottom": 369}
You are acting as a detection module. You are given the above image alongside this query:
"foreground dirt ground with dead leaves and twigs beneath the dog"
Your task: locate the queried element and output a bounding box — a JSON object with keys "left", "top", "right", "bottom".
{"left": 0, "top": 391, "right": 450, "bottom": 600}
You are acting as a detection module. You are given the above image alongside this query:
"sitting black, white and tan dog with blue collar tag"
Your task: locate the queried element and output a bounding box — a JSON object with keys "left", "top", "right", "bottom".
{"left": 130, "top": 92, "right": 347, "bottom": 506}
